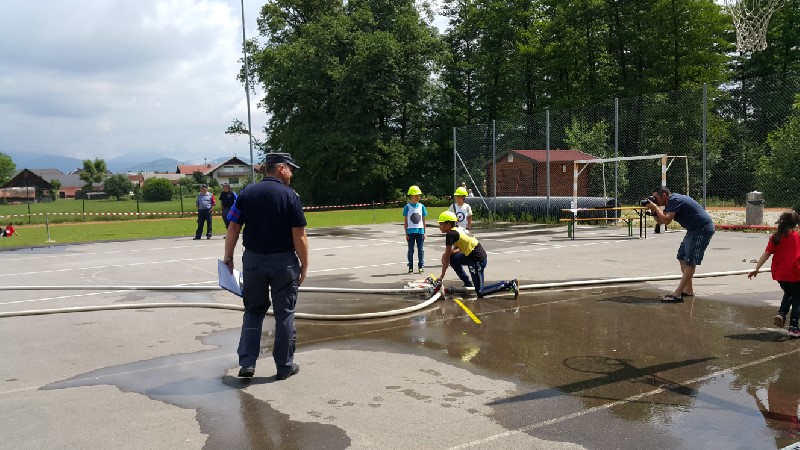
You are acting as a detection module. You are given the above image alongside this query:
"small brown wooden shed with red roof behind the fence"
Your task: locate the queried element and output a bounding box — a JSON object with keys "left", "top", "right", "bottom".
{"left": 486, "top": 150, "right": 597, "bottom": 197}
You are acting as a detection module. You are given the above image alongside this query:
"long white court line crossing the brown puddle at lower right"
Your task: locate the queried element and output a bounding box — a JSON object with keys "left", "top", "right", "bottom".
{"left": 449, "top": 348, "right": 800, "bottom": 450}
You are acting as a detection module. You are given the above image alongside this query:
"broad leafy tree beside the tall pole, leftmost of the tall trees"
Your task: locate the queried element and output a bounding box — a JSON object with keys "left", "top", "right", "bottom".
{"left": 252, "top": 0, "right": 439, "bottom": 203}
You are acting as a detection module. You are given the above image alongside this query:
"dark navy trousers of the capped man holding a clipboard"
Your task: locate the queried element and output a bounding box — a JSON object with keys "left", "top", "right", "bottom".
{"left": 237, "top": 250, "right": 300, "bottom": 374}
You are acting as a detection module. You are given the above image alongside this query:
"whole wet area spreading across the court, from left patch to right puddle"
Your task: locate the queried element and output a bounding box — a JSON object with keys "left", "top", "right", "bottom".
{"left": 40, "top": 287, "right": 800, "bottom": 448}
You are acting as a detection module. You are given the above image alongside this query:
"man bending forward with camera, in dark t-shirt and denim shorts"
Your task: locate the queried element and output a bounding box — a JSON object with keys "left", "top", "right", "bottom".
{"left": 642, "top": 186, "right": 714, "bottom": 303}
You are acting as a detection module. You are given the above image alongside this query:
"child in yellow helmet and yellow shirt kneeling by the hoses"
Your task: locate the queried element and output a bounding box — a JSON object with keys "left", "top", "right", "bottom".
{"left": 439, "top": 211, "right": 519, "bottom": 298}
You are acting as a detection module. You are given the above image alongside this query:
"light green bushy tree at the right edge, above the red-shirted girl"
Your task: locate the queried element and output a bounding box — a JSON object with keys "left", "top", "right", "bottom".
{"left": 756, "top": 95, "right": 800, "bottom": 207}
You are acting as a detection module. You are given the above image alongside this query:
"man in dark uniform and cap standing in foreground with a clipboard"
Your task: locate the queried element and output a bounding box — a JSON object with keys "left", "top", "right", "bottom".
{"left": 223, "top": 153, "right": 308, "bottom": 380}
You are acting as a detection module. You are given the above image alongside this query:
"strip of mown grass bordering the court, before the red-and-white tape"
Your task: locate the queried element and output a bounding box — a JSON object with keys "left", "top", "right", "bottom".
{"left": 0, "top": 206, "right": 446, "bottom": 250}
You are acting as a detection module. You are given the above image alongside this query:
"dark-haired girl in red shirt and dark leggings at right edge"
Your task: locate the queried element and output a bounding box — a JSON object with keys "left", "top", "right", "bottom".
{"left": 747, "top": 211, "right": 800, "bottom": 337}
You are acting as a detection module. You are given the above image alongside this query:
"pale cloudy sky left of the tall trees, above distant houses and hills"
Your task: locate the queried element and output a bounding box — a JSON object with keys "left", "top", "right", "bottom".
{"left": 0, "top": 0, "right": 266, "bottom": 163}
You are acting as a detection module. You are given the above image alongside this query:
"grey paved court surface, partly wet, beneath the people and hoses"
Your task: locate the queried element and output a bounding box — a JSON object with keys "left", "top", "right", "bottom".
{"left": 0, "top": 224, "right": 800, "bottom": 449}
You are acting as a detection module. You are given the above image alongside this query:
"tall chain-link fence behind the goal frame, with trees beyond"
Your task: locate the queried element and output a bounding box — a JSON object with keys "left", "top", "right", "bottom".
{"left": 453, "top": 73, "right": 800, "bottom": 218}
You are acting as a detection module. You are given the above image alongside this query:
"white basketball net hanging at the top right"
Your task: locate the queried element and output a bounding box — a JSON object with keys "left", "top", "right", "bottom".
{"left": 725, "top": 0, "right": 782, "bottom": 53}
